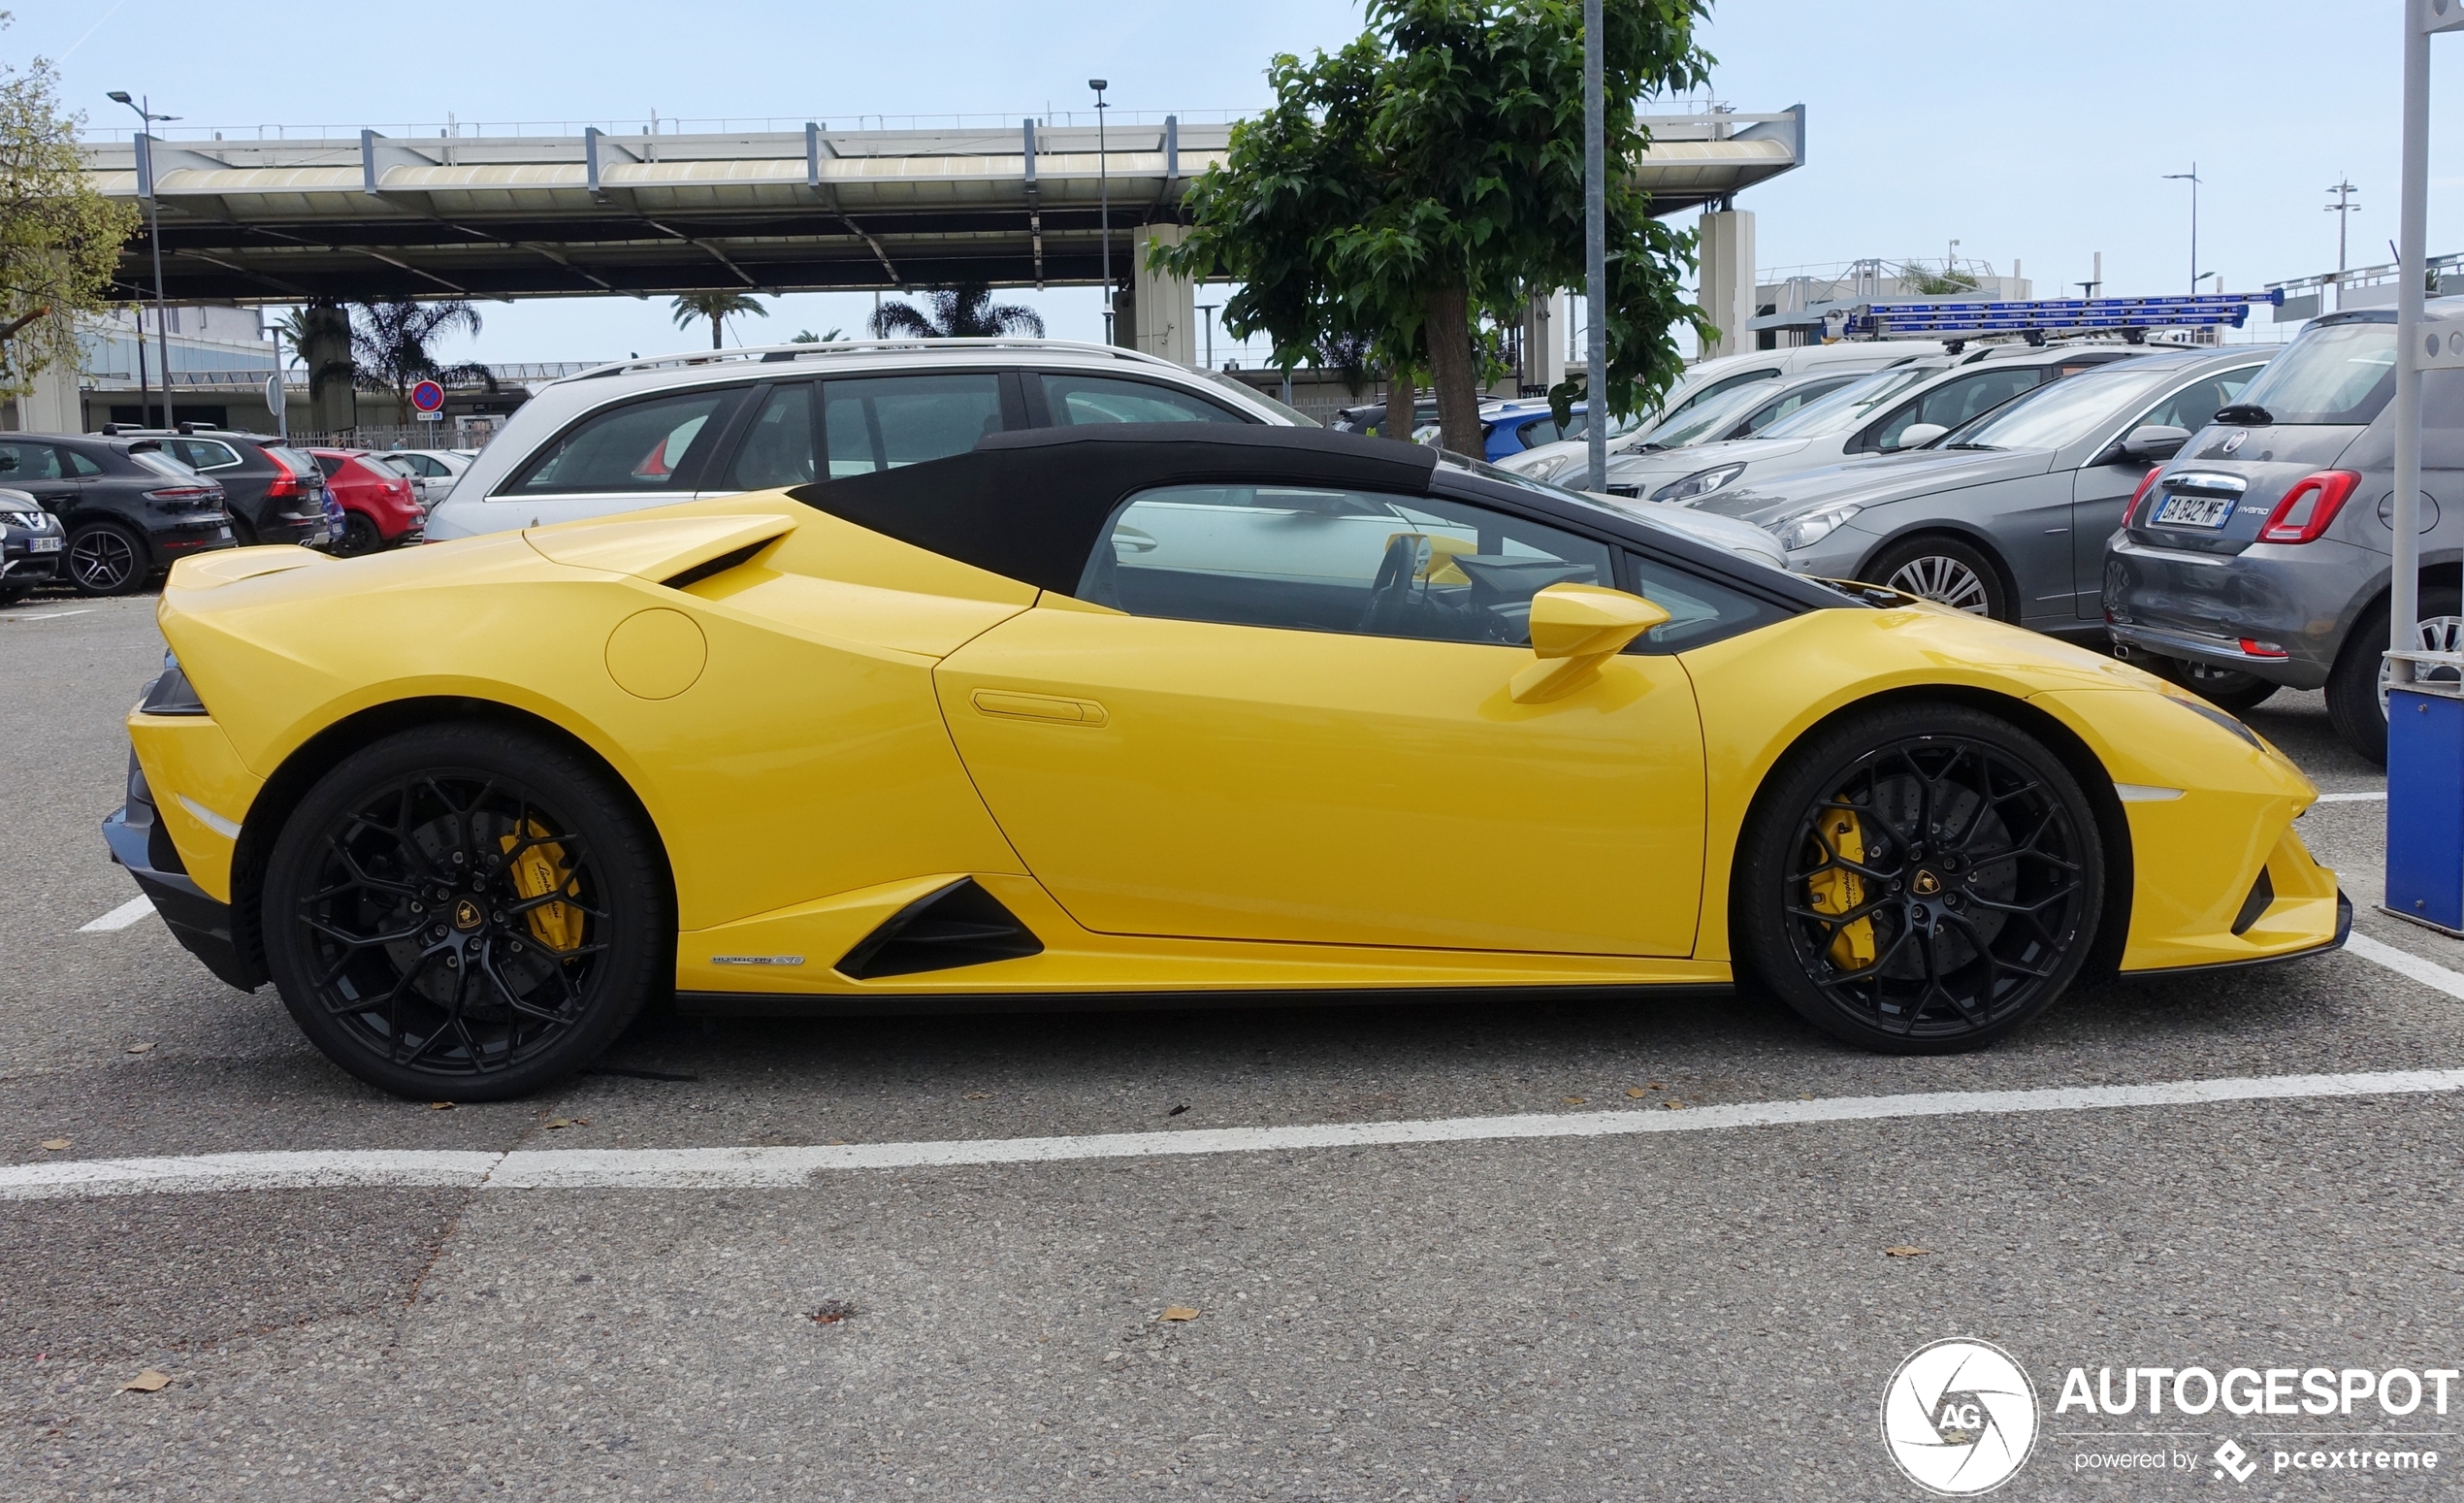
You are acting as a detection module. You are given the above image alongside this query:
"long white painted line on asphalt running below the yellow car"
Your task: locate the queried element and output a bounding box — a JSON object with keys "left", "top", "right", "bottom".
{"left": 0, "top": 1069, "right": 2464, "bottom": 1200}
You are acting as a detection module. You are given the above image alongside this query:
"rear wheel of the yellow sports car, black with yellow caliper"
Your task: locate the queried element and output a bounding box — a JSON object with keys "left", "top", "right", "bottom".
{"left": 264, "top": 725, "right": 675, "bottom": 1101}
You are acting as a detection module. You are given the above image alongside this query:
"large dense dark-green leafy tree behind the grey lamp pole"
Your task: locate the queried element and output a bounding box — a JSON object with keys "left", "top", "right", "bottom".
{"left": 1153, "top": 0, "right": 1717, "bottom": 453}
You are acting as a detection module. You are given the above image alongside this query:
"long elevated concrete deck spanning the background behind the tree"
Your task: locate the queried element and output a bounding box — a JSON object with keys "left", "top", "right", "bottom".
{"left": 83, "top": 106, "right": 1803, "bottom": 303}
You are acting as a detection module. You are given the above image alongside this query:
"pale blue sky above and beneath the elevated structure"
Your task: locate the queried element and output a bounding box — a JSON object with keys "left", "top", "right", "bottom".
{"left": 0, "top": 0, "right": 2464, "bottom": 360}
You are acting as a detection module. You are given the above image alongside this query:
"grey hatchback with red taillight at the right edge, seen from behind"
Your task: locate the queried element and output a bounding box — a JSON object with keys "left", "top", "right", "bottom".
{"left": 2104, "top": 298, "right": 2464, "bottom": 762}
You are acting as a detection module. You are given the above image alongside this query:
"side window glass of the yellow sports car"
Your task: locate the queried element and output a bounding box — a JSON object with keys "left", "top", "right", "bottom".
{"left": 1077, "top": 485, "right": 1616, "bottom": 645}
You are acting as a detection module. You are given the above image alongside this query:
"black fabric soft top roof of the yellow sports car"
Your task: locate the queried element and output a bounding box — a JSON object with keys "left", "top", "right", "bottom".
{"left": 789, "top": 424, "right": 1437, "bottom": 594}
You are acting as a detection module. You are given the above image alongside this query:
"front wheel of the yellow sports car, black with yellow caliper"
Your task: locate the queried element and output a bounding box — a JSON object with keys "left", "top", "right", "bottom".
{"left": 1730, "top": 702, "right": 2104, "bottom": 1055}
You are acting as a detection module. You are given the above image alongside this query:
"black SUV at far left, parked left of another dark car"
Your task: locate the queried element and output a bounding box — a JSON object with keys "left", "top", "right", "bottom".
{"left": 0, "top": 434, "right": 232, "bottom": 594}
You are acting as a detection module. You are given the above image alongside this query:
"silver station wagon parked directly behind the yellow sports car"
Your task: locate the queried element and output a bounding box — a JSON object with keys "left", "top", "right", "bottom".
{"left": 429, "top": 340, "right": 1315, "bottom": 542}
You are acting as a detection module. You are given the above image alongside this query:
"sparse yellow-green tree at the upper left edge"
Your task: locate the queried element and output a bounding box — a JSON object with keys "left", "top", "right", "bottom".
{"left": 0, "top": 10, "right": 138, "bottom": 394}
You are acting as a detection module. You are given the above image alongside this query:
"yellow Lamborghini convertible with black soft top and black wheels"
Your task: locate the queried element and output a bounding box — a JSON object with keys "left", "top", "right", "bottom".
{"left": 104, "top": 424, "right": 2351, "bottom": 1099}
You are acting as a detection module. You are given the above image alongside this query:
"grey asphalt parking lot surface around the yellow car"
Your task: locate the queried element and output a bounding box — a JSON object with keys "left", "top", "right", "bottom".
{"left": 0, "top": 599, "right": 2464, "bottom": 1500}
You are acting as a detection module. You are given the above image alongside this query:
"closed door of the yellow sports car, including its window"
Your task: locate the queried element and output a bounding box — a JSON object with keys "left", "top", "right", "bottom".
{"left": 936, "top": 485, "right": 1702, "bottom": 956}
